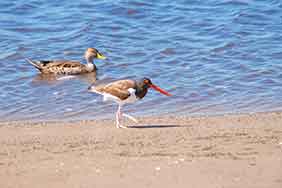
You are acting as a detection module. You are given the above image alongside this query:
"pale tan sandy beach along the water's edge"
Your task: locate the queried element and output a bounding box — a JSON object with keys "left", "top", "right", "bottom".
{"left": 0, "top": 113, "right": 282, "bottom": 188}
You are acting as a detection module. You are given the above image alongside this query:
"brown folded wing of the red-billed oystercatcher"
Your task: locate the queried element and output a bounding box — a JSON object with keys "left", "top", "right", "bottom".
{"left": 95, "top": 80, "right": 135, "bottom": 100}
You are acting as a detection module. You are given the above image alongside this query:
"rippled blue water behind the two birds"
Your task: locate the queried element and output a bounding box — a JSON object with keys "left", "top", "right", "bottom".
{"left": 0, "top": 0, "right": 282, "bottom": 121}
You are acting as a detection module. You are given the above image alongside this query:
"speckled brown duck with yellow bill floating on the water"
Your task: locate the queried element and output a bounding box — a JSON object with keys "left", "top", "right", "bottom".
{"left": 26, "top": 48, "right": 106, "bottom": 75}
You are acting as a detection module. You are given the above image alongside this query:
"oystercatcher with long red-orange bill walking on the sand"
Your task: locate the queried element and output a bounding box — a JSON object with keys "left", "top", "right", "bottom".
{"left": 88, "top": 78, "right": 171, "bottom": 128}
